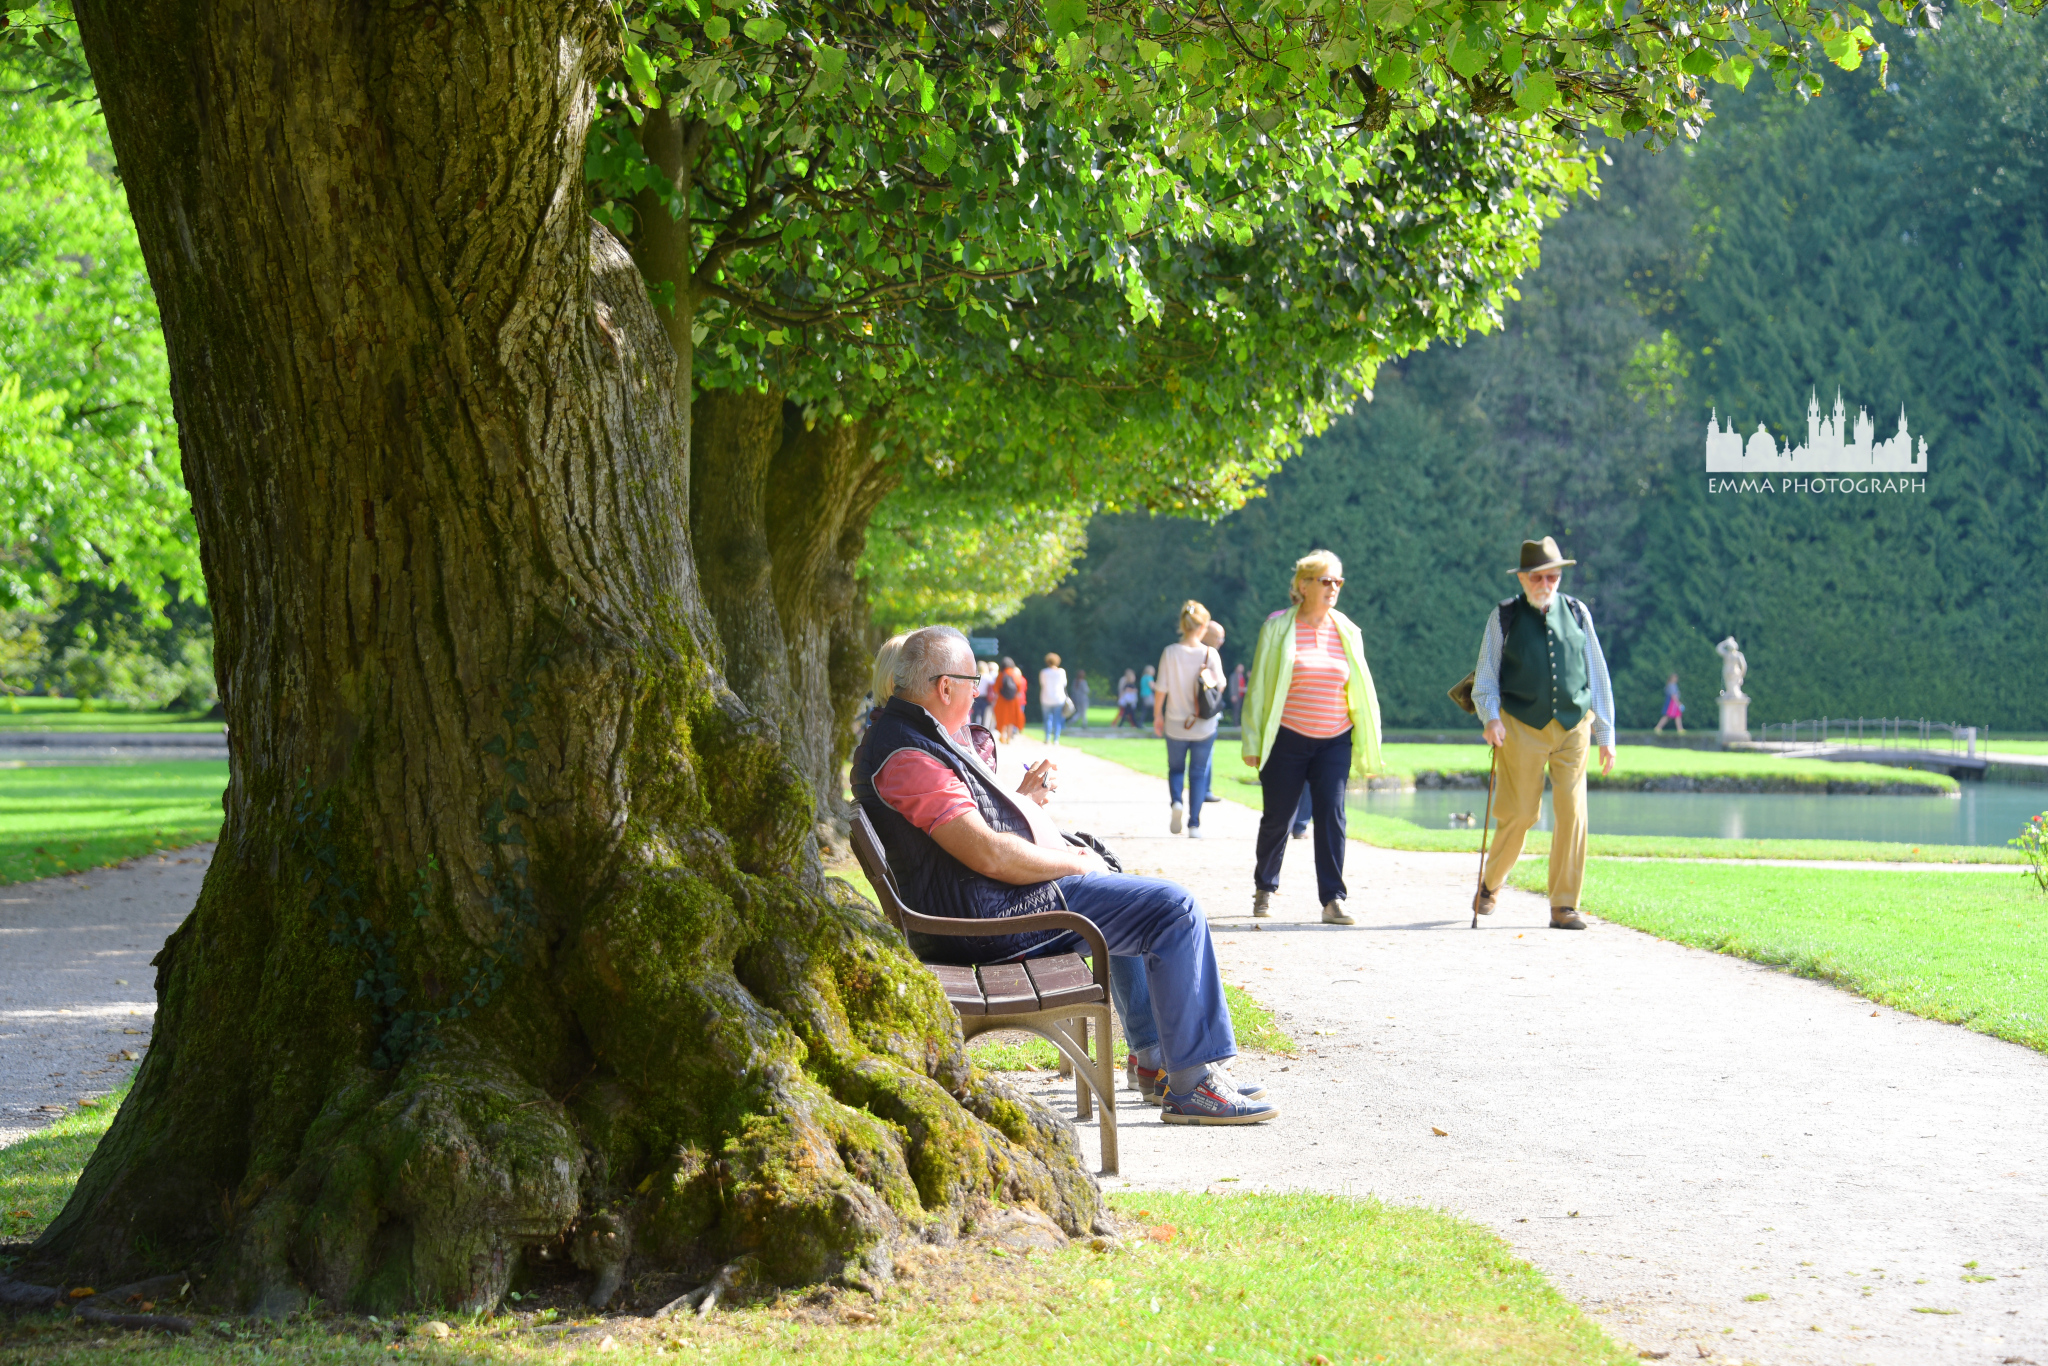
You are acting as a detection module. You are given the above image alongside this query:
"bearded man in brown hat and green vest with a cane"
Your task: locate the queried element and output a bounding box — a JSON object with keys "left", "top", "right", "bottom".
{"left": 1473, "top": 537, "right": 1614, "bottom": 930}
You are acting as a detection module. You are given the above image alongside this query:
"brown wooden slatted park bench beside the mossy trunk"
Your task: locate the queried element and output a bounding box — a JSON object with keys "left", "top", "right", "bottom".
{"left": 854, "top": 807, "right": 1116, "bottom": 1176}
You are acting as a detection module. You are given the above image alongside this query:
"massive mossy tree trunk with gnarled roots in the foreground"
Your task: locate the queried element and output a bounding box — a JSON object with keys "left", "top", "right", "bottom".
{"left": 31, "top": 0, "right": 1098, "bottom": 1311}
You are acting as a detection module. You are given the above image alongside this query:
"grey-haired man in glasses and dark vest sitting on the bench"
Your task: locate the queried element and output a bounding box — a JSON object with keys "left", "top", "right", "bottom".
{"left": 854, "top": 627, "right": 1280, "bottom": 1124}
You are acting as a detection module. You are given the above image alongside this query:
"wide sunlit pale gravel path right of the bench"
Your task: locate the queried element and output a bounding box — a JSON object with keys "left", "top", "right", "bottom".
{"left": 995, "top": 745, "right": 2048, "bottom": 1366}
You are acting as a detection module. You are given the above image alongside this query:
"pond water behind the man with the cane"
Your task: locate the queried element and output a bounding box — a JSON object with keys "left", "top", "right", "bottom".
{"left": 1352, "top": 782, "right": 2048, "bottom": 844}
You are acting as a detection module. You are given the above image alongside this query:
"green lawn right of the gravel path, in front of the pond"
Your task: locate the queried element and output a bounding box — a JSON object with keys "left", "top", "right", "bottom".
{"left": 1509, "top": 860, "right": 2048, "bottom": 1051}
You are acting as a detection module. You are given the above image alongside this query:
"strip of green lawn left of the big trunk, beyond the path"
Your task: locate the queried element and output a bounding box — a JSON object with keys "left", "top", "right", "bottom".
{"left": 0, "top": 760, "right": 227, "bottom": 883}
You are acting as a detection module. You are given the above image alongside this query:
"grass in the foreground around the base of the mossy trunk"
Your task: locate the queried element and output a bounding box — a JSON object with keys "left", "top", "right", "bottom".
{"left": 0, "top": 1098, "right": 1634, "bottom": 1366}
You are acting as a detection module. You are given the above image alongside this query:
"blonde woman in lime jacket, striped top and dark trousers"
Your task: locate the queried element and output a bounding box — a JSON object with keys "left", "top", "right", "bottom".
{"left": 1243, "top": 551, "right": 1380, "bottom": 926}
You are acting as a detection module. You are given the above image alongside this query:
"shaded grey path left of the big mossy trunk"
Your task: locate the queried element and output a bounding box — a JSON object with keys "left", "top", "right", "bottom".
{"left": 0, "top": 844, "right": 213, "bottom": 1147}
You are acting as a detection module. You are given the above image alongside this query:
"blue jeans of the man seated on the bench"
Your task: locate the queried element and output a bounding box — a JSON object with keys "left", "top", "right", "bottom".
{"left": 1030, "top": 872, "right": 1237, "bottom": 1069}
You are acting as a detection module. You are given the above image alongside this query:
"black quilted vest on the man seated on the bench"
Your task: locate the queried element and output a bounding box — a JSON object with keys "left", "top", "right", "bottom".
{"left": 852, "top": 696, "right": 1067, "bottom": 963}
